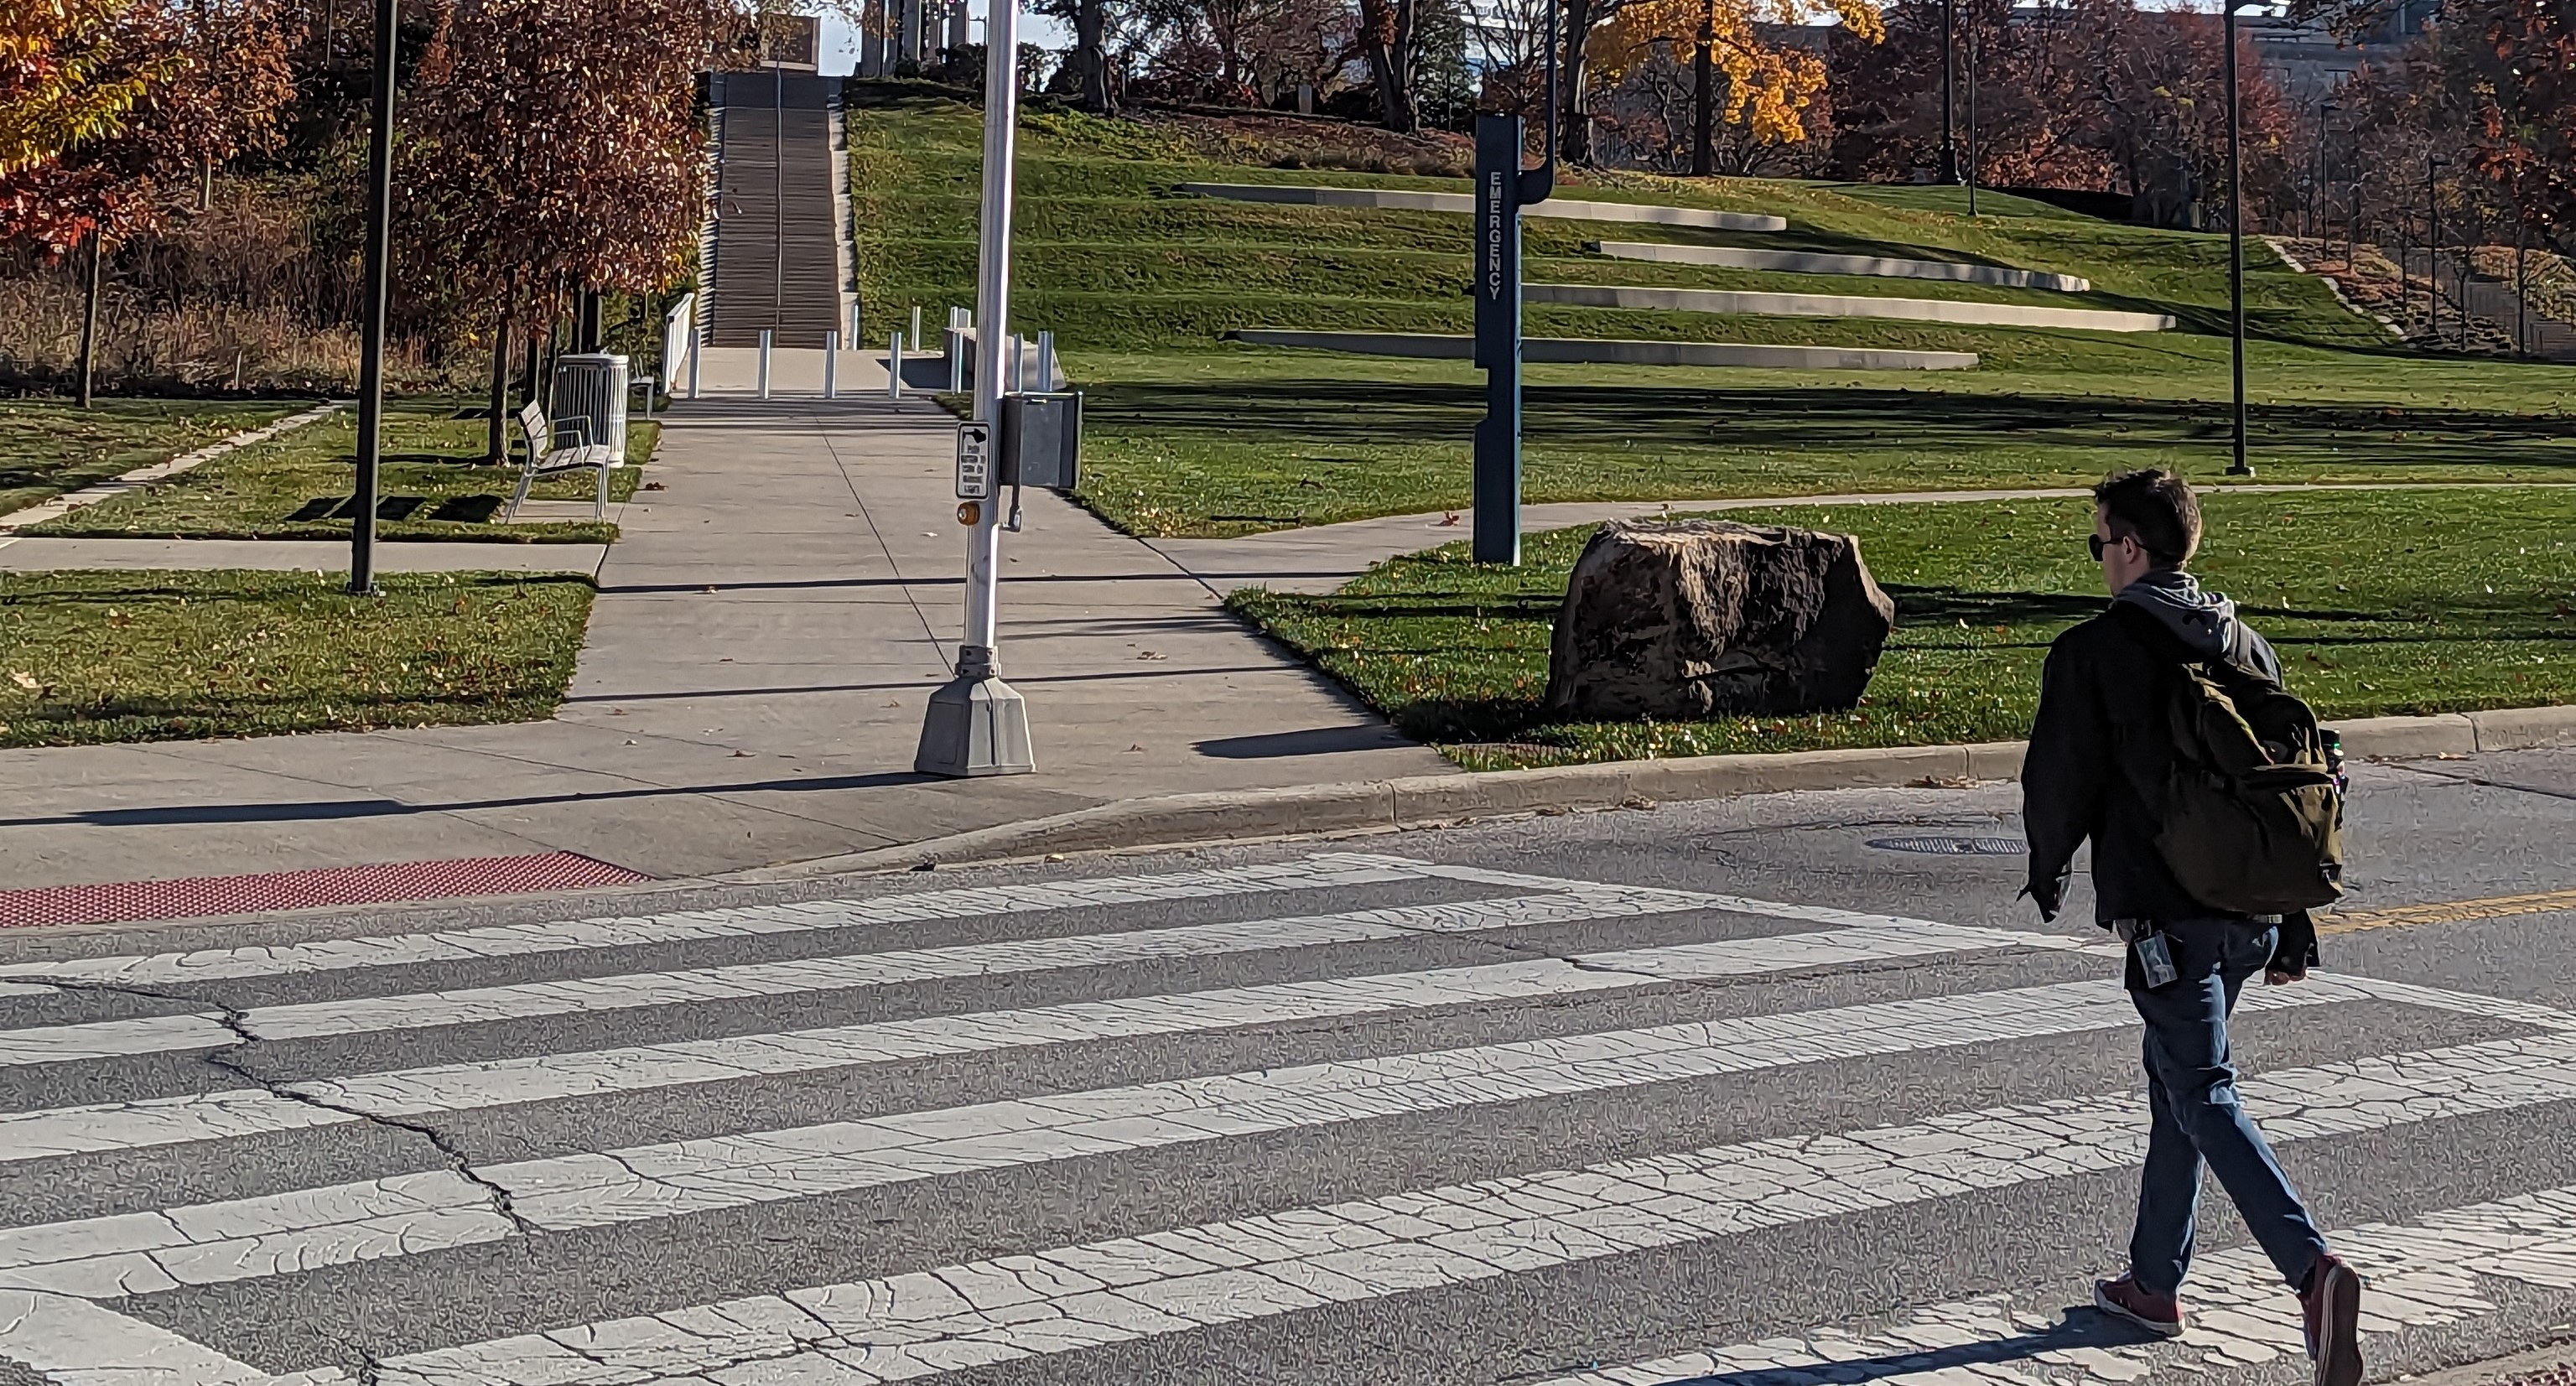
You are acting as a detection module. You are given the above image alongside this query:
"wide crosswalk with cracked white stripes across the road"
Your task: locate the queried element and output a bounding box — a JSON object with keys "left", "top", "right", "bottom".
{"left": 0, "top": 853, "right": 2576, "bottom": 1386}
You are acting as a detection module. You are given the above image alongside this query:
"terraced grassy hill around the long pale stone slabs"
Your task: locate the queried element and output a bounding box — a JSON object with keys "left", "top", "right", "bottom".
{"left": 850, "top": 82, "right": 2576, "bottom": 533}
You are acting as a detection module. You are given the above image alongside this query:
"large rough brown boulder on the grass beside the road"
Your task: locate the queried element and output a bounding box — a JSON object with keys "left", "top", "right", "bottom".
{"left": 1548, "top": 521, "right": 1896, "bottom": 721}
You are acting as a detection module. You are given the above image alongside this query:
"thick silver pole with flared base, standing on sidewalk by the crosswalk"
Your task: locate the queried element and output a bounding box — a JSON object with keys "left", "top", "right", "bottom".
{"left": 911, "top": 0, "right": 1038, "bottom": 776}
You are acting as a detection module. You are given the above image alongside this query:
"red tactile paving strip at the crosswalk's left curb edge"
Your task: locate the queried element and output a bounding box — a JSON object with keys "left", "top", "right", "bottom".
{"left": 0, "top": 853, "right": 647, "bottom": 925}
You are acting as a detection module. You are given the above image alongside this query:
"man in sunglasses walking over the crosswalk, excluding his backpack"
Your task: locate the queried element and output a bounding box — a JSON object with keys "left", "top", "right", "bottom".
{"left": 2023, "top": 471, "right": 2362, "bottom": 1386}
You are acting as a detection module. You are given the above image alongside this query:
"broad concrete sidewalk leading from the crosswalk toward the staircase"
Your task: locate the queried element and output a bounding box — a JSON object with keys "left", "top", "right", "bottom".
{"left": 0, "top": 399, "right": 1451, "bottom": 889}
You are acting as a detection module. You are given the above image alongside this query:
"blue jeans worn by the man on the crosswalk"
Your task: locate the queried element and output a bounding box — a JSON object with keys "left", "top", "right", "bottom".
{"left": 2127, "top": 920, "right": 2326, "bottom": 1295}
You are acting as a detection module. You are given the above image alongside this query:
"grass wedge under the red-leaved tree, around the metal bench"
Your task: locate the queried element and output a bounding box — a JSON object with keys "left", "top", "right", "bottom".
{"left": 29, "top": 397, "right": 662, "bottom": 543}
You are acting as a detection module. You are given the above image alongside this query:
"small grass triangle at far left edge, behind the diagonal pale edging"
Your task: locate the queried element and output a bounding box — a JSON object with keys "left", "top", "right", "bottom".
{"left": 0, "top": 399, "right": 301, "bottom": 515}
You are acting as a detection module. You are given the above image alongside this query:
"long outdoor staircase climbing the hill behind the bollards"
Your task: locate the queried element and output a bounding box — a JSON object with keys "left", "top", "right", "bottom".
{"left": 704, "top": 72, "right": 855, "bottom": 348}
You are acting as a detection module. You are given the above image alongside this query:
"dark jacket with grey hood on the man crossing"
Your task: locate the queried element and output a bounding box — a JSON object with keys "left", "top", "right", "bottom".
{"left": 2023, "top": 572, "right": 2280, "bottom": 922}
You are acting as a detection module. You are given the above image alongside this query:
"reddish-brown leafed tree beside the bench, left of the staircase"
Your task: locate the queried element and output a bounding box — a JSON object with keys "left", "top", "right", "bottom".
{"left": 397, "top": 0, "right": 747, "bottom": 456}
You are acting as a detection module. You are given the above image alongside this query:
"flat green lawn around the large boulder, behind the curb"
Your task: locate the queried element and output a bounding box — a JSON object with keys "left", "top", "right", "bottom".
{"left": 1231, "top": 487, "right": 2576, "bottom": 768}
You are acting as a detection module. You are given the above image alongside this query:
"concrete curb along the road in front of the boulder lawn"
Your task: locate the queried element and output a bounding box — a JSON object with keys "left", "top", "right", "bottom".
{"left": 752, "top": 706, "right": 2576, "bottom": 881}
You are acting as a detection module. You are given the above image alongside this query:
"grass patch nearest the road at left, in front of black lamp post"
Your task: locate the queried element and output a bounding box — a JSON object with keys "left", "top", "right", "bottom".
{"left": 0, "top": 572, "right": 593, "bottom": 747}
